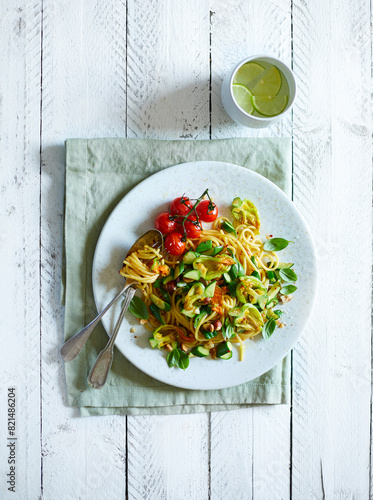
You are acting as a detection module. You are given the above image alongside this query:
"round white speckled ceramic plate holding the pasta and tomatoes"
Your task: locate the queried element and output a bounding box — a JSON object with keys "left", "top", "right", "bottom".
{"left": 93, "top": 161, "right": 316, "bottom": 389}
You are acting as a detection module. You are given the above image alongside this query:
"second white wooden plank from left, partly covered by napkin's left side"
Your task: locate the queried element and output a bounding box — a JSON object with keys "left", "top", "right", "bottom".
{"left": 41, "top": 0, "right": 126, "bottom": 500}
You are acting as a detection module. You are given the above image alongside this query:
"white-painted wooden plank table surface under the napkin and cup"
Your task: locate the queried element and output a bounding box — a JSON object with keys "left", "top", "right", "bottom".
{"left": 0, "top": 0, "right": 373, "bottom": 500}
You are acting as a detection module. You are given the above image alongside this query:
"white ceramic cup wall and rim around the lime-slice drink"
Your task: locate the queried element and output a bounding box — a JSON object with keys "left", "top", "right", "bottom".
{"left": 221, "top": 55, "right": 297, "bottom": 128}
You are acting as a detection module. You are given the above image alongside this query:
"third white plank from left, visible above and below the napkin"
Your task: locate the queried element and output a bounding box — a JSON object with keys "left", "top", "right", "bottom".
{"left": 127, "top": 0, "right": 209, "bottom": 500}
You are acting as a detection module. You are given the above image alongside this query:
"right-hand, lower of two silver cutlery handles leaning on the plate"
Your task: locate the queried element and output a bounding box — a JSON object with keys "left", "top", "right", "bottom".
{"left": 87, "top": 287, "right": 136, "bottom": 389}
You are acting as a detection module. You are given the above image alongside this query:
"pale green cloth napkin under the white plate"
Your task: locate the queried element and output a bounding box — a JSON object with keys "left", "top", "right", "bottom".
{"left": 63, "top": 138, "right": 291, "bottom": 416}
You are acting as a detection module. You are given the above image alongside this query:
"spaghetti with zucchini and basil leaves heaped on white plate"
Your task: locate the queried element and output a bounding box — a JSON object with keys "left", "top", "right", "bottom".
{"left": 120, "top": 198, "right": 297, "bottom": 368}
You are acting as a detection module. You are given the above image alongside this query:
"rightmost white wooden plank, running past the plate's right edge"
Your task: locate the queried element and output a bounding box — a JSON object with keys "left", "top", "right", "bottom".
{"left": 292, "top": 0, "right": 372, "bottom": 499}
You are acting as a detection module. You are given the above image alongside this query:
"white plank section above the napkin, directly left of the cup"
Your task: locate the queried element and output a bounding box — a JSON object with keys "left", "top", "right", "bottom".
{"left": 127, "top": 0, "right": 210, "bottom": 139}
